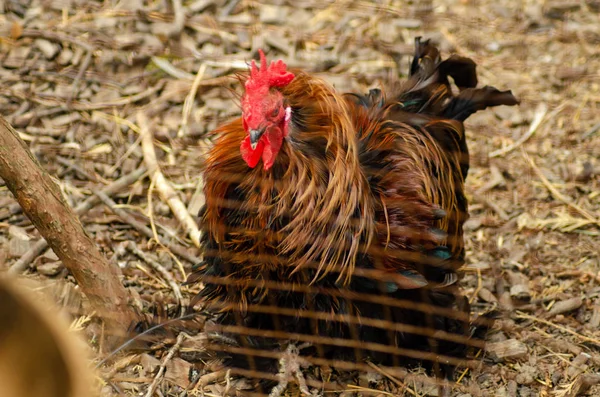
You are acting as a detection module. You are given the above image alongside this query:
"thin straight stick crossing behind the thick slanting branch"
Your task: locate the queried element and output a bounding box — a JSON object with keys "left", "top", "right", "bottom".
{"left": 8, "top": 166, "right": 146, "bottom": 274}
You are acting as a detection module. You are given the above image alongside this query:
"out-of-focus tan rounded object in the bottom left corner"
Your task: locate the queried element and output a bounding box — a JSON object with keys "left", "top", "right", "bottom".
{"left": 0, "top": 277, "right": 94, "bottom": 397}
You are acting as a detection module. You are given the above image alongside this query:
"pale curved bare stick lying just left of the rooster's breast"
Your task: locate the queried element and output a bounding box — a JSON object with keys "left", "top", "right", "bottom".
{"left": 137, "top": 111, "right": 200, "bottom": 247}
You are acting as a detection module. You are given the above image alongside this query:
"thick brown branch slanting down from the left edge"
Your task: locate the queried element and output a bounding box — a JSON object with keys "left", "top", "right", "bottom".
{"left": 0, "top": 117, "right": 138, "bottom": 343}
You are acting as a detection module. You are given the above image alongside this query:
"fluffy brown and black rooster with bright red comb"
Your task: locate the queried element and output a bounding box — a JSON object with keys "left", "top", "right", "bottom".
{"left": 188, "top": 39, "right": 517, "bottom": 382}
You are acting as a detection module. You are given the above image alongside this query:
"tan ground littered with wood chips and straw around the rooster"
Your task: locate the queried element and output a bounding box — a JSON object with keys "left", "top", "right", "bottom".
{"left": 0, "top": 0, "right": 600, "bottom": 397}
